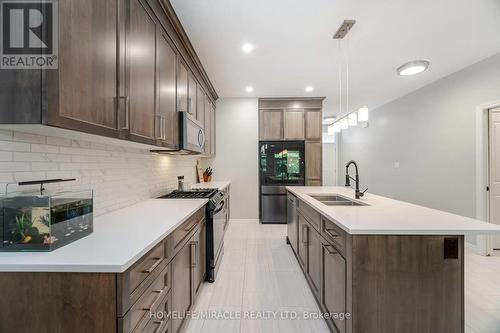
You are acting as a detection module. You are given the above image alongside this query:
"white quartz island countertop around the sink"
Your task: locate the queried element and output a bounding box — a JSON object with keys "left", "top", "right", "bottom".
{"left": 287, "top": 186, "right": 500, "bottom": 235}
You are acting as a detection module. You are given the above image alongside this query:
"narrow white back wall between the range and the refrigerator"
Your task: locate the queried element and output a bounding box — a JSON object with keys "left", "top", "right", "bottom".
{"left": 208, "top": 98, "right": 259, "bottom": 219}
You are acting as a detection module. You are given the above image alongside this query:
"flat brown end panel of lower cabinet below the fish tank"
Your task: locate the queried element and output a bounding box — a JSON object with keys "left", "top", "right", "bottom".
{"left": 0, "top": 273, "right": 117, "bottom": 333}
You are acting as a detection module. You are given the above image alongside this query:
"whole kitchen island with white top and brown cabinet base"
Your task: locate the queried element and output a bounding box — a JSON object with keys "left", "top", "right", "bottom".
{"left": 287, "top": 187, "right": 500, "bottom": 333}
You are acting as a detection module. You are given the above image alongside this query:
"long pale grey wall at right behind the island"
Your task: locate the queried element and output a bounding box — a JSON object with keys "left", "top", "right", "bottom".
{"left": 339, "top": 54, "right": 500, "bottom": 217}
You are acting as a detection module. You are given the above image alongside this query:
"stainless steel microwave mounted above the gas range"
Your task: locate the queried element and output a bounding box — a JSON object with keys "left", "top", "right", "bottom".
{"left": 151, "top": 112, "right": 205, "bottom": 155}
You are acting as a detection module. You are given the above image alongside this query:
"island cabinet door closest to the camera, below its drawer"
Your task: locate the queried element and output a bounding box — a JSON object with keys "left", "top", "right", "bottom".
{"left": 321, "top": 242, "right": 346, "bottom": 333}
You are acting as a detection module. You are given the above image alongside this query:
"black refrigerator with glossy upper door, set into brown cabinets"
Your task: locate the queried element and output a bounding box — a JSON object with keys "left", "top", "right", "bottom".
{"left": 259, "top": 141, "right": 305, "bottom": 224}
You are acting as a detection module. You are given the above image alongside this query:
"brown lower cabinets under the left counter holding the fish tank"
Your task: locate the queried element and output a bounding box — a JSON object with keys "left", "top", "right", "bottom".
{"left": 0, "top": 207, "right": 206, "bottom": 333}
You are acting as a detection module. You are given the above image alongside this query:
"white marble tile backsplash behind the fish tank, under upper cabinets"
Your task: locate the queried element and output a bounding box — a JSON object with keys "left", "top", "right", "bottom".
{"left": 0, "top": 130, "right": 197, "bottom": 216}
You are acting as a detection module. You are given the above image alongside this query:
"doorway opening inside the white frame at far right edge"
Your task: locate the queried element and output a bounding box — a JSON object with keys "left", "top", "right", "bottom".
{"left": 488, "top": 107, "right": 500, "bottom": 250}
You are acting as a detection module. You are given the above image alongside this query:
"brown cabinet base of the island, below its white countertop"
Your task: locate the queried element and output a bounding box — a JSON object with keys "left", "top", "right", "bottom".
{"left": 288, "top": 194, "right": 465, "bottom": 333}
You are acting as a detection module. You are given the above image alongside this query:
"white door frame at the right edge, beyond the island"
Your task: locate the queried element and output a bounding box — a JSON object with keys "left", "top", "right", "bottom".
{"left": 475, "top": 100, "right": 500, "bottom": 255}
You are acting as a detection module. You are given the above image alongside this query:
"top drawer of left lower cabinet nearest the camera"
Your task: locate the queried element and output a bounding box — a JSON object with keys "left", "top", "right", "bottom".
{"left": 118, "top": 241, "right": 169, "bottom": 316}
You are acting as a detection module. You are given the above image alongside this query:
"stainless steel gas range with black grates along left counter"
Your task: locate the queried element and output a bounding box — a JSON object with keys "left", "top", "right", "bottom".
{"left": 159, "top": 189, "right": 228, "bottom": 282}
